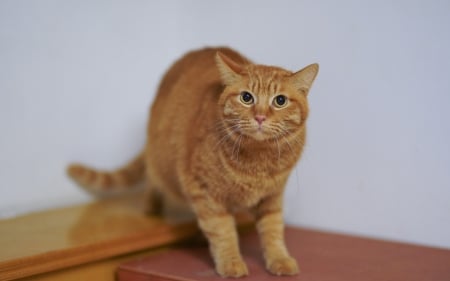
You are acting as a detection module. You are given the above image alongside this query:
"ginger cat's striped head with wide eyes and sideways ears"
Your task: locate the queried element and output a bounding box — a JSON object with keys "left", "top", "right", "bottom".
{"left": 216, "top": 52, "right": 319, "bottom": 141}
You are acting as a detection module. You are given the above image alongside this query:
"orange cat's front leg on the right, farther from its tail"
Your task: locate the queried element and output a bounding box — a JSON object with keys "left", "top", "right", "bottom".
{"left": 255, "top": 194, "right": 299, "bottom": 275}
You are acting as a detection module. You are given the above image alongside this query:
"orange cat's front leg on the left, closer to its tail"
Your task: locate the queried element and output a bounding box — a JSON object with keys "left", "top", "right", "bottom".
{"left": 191, "top": 192, "right": 248, "bottom": 277}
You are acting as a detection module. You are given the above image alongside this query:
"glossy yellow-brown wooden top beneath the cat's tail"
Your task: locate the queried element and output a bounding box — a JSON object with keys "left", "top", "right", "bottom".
{"left": 0, "top": 194, "right": 198, "bottom": 280}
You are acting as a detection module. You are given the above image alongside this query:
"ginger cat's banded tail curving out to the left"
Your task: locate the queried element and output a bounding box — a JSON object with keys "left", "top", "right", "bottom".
{"left": 67, "top": 153, "right": 145, "bottom": 193}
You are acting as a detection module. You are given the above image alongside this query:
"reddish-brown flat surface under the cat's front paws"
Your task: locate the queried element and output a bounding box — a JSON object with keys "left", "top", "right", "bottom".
{"left": 118, "top": 227, "right": 450, "bottom": 281}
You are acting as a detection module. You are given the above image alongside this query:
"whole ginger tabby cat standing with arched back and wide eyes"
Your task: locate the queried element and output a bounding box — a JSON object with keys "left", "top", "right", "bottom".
{"left": 68, "top": 48, "right": 318, "bottom": 277}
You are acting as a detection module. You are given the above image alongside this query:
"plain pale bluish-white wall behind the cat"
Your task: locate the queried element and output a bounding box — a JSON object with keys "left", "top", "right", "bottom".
{"left": 0, "top": 0, "right": 450, "bottom": 248}
